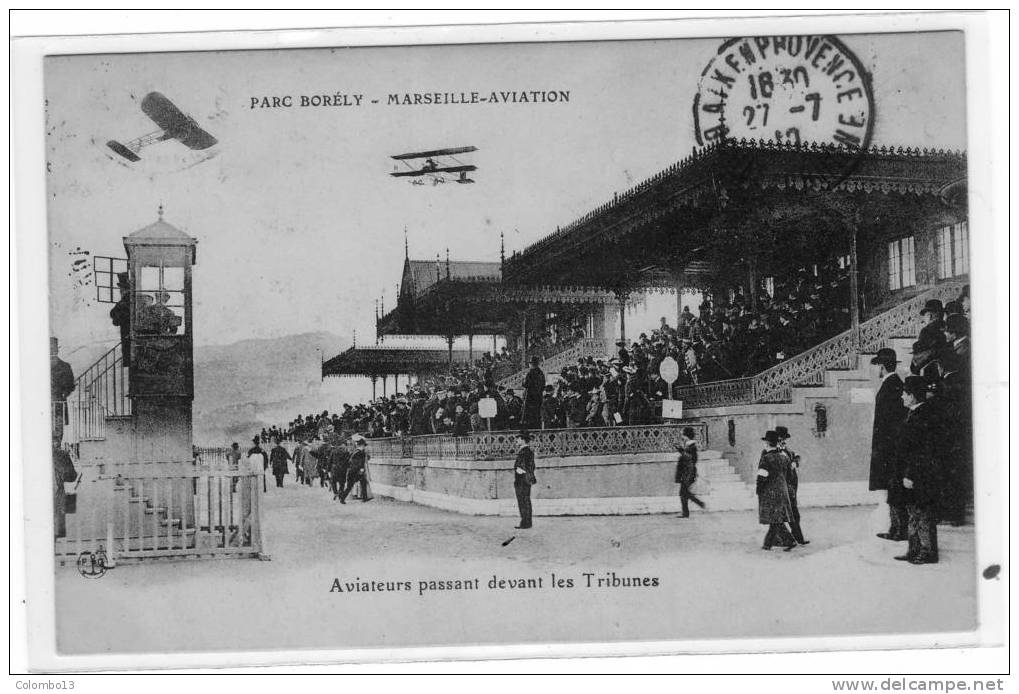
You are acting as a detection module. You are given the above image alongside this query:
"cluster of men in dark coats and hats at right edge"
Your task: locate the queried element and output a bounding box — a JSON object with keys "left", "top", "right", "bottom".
{"left": 870, "top": 289, "right": 973, "bottom": 565}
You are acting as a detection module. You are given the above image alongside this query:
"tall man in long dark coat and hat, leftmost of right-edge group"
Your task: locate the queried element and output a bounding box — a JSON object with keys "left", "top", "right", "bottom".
{"left": 870, "top": 348, "right": 908, "bottom": 542}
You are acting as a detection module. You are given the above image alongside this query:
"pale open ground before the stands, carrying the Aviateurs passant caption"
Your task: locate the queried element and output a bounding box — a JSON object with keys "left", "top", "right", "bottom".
{"left": 56, "top": 478, "right": 976, "bottom": 653}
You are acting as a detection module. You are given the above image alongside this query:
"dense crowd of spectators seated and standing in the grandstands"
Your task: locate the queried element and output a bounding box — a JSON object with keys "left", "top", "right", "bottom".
{"left": 261, "top": 264, "right": 968, "bottom": 440}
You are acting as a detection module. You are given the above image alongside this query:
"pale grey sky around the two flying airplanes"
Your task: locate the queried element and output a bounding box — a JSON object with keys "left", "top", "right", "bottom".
{"left": 44, "top": 33, "right": 966, "bottom": 349}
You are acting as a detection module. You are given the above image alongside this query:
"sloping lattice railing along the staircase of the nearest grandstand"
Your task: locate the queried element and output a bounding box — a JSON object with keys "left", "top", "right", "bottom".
{"left": 675, "top": 282, "right": 963, "bottom": 409}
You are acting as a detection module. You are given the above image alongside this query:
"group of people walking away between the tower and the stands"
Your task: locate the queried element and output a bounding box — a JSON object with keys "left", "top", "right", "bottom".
{"left": 232, "top": 432, "right": 372, "bottom": 503}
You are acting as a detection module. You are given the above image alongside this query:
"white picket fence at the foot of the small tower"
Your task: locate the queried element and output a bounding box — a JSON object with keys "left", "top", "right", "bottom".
{"left": 55, "top": 463, "right": 263, "bottom": 566}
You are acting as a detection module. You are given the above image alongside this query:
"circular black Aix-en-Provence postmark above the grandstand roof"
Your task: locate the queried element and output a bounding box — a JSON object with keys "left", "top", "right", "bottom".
{"left": 694, "top": 36, "right": 874, "bottom": 170}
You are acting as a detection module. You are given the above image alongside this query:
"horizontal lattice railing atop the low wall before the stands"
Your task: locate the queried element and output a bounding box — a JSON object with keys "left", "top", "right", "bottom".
{"left": 368, "top": 422, "right": 707, "bottom": 461}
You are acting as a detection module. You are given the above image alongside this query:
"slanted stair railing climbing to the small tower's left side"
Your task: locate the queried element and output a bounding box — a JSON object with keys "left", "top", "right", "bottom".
{"left": 64, "top": 342, "right": 131, "bottom": 443}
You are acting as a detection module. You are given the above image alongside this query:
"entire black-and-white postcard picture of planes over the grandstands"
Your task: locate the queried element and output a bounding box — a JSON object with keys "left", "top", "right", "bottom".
{"left": 15, "top": 13, "right": 1006, "bottom": 658}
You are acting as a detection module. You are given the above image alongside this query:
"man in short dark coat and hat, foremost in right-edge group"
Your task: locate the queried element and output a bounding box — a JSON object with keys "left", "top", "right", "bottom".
{"left": 896, "top": 376, "right": 941, "bottom": 564}
